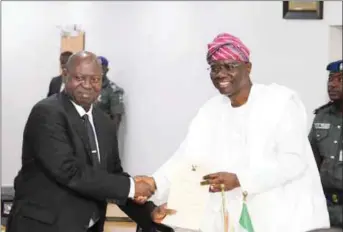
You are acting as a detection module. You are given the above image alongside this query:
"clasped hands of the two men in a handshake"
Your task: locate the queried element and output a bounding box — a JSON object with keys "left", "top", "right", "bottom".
{"left": 133, "top": 176, "right": 156, "bottom": 204}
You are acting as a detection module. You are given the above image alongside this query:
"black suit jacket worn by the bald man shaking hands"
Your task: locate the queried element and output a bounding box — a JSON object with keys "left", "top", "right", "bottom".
{"left": 7, "top": 92, "right": 155, "bottom": 232}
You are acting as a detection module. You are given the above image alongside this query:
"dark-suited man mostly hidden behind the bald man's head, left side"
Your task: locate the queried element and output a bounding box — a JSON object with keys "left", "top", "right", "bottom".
{"left": 48, "top": 51, "right": 73, "bottom": 97}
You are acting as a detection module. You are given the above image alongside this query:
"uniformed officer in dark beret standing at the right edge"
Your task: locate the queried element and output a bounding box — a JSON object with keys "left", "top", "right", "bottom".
{"left": 309, "top": 60, "right": 343, "bottom": 228}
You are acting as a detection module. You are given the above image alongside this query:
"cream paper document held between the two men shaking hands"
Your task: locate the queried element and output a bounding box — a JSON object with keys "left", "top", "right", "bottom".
{"left": 162, "top": 162, "right": 210, "bottom": 230}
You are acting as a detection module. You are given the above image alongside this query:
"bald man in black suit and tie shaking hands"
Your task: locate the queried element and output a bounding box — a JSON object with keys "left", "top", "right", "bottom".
{"left": 7, "top": 52, "right": 157, "bottom": 232}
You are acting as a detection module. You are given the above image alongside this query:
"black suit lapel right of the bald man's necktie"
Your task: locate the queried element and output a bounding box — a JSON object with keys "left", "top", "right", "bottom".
{"left": 93, "top": 107, "right": 107, "bottom": 169}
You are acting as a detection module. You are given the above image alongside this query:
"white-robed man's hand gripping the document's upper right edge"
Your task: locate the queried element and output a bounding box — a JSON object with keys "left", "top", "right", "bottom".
{"left": 203, "top": 172, "right": 240, "bottom": 192}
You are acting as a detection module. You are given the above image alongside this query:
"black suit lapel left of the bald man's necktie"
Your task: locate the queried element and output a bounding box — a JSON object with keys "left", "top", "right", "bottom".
{"left": 59, "top": 91, "right": 92, "bottom": 160}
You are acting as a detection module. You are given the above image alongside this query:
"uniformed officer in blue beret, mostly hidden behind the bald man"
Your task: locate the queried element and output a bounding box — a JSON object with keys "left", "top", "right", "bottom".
{"left": 96, "top": 56, "right": 124, "bottom": 129}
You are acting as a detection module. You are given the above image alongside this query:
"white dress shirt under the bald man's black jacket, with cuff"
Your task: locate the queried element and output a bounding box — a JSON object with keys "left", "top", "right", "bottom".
{"left": 71, "top": 101, "right": 135, "bottom": 227}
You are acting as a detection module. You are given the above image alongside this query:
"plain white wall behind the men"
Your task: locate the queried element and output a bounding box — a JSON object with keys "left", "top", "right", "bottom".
{"left": 1, "top": 1, "right": 342, "bottom": 185}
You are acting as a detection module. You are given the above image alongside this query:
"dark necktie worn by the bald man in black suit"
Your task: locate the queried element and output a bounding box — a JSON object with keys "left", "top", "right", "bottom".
{"left": 82, "top": 114, "right": 100, "bottom": 226}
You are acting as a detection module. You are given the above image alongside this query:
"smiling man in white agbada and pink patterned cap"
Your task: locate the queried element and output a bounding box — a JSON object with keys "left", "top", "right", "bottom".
{"left": 146, "top": 33, "right": 330, "bottom": 232}
